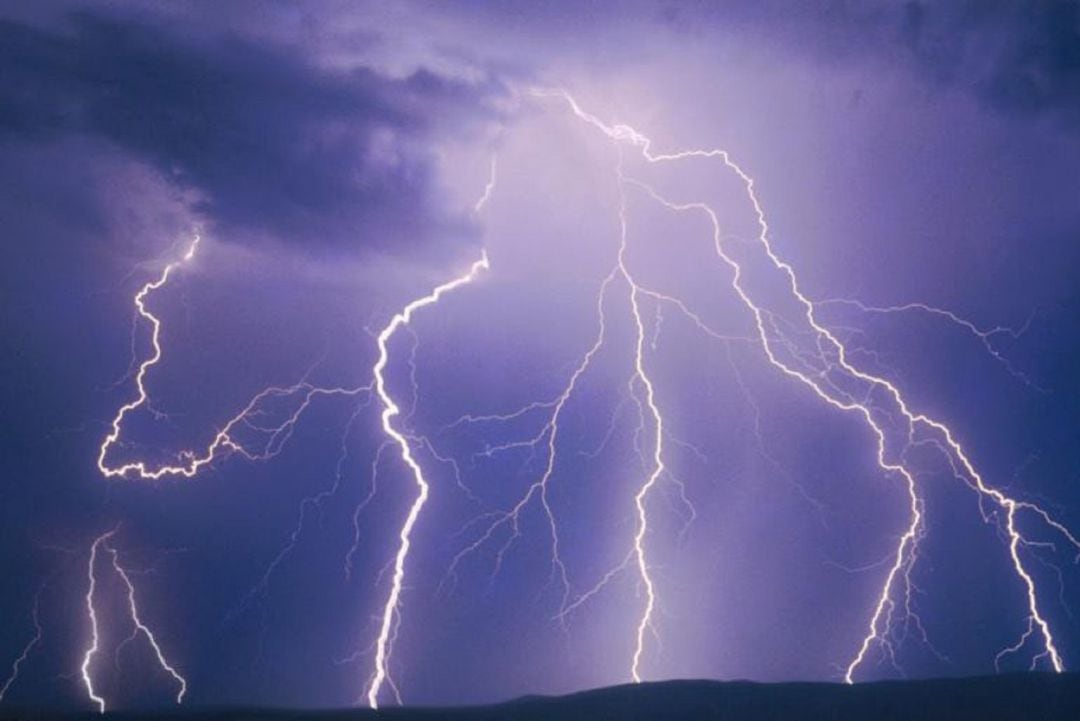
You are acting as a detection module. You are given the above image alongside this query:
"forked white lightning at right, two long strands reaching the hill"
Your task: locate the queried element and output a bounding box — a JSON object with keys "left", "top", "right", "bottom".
{"left": 532, "top": 90, "right": 1080, "bottom": 683}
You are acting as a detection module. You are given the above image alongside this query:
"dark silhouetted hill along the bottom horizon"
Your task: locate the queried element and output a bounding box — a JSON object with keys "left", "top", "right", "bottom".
{"left": 0, "top": 674, "right": 1080, "bottom": 721}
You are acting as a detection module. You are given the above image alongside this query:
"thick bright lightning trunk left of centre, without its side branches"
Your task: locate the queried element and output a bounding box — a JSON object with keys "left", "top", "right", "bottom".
{"left": 366, "top": 251, "right": 490, "bottom": 708}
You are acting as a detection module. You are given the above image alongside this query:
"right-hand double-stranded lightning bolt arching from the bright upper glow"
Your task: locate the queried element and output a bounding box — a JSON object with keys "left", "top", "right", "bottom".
{"left": 530, "top": 90, "right": 1080, "bottom": 683}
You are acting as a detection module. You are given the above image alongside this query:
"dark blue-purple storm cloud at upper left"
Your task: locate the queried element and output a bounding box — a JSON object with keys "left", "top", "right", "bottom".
{"left": 0, "top": 13, "right": 499, "bottom": 253}
